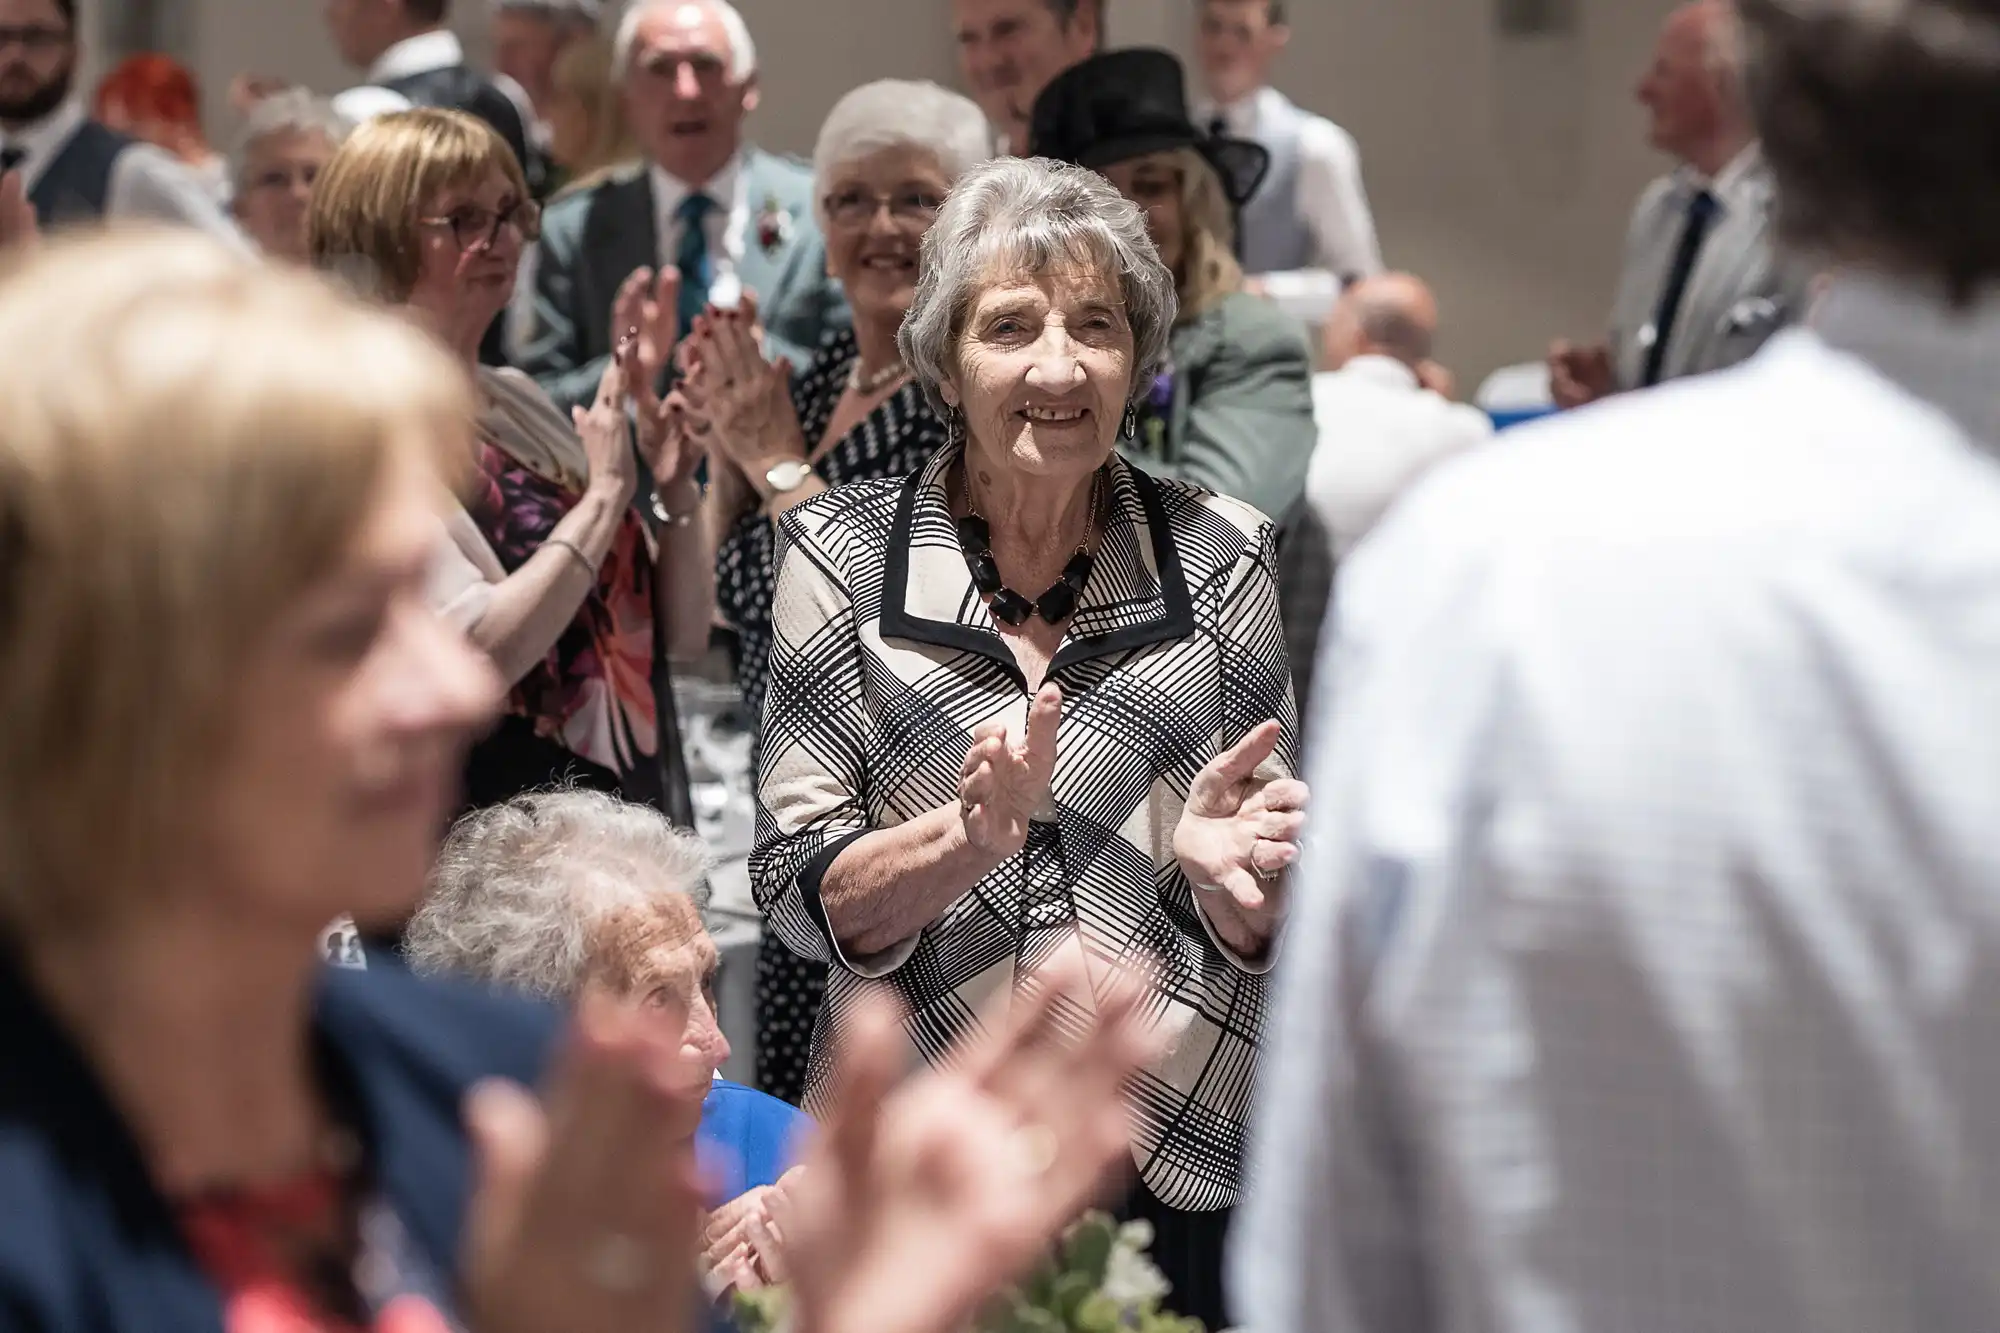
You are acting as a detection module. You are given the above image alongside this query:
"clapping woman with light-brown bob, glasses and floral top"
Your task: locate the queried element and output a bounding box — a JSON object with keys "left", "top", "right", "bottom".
{"left": 308, "top": 108, "right": 714, "bottom": 820}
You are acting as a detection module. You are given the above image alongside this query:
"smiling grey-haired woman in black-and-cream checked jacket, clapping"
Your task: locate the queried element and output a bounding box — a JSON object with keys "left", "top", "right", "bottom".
{"left": 752, "top": 160, "right": 1306, "bottom": 1323}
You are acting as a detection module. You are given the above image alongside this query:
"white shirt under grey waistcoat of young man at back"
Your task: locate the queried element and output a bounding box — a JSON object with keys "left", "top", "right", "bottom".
{"left": 1196, "top": 88, "right": 1382, "bottom": 324}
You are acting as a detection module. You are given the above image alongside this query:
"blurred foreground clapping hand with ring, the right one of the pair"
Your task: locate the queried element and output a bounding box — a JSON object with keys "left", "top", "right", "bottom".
{"left": 778, "top": 957, "right": 1156, "bottom": 1333}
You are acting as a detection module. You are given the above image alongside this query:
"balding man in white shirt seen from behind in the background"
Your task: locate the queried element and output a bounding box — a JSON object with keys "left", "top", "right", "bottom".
{"left": 1306, "top": 272, "right": 1494, "bottom": 558}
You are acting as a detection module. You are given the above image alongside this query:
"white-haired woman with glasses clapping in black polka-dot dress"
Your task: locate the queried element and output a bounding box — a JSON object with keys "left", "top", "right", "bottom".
{"left": 682, "top": 80, "right": 990, "bottom": 1101}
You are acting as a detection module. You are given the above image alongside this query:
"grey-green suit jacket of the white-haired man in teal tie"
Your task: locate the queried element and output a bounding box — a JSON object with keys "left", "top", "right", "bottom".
{"left": 518, "top": 148, "right": 848, "bottom": 410}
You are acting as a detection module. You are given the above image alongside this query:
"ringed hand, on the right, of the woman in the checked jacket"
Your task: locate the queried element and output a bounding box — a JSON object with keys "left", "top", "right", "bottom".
{"left": 1174, "top": 723, "right": 1308, "bottom": 917}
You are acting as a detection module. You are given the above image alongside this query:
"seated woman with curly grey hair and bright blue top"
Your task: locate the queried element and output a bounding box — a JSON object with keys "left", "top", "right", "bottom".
{"left": 402, "top": 791, "right": 806, "bottom": 1289}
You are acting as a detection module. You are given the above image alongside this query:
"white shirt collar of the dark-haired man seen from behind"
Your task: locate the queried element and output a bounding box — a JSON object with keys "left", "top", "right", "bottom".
{"left": 1806, "top": 270, "right": 2000, "bottom": 452}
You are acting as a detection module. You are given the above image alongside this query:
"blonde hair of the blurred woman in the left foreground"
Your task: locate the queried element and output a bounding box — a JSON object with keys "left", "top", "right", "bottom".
{"left": 0, "top": 228, "right": 472, "bottom": 935}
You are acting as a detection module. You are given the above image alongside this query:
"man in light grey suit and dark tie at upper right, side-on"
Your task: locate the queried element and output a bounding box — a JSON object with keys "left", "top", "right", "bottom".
{"left": 1548, "top": 0, "right": 1810, "bottom": 406}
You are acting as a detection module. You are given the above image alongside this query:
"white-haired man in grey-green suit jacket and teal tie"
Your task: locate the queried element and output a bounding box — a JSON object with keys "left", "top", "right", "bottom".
{"left": 520, "top": 0, "right": 848, "bottom": 406}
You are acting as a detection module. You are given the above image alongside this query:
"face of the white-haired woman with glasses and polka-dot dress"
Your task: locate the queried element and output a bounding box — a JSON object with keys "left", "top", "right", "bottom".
{"left": 820, "top": 146, "right": 952, "bottom": 326}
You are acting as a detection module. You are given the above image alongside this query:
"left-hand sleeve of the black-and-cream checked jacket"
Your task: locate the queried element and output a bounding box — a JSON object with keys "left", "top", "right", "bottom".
{"left": 750, "top": 510, "right": 876, "bottom": 971}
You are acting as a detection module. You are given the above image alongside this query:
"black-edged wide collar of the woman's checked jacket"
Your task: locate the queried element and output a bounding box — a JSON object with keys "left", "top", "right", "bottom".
{"left": 882, "top": 446, "right": 1194, "bottom": 677}
